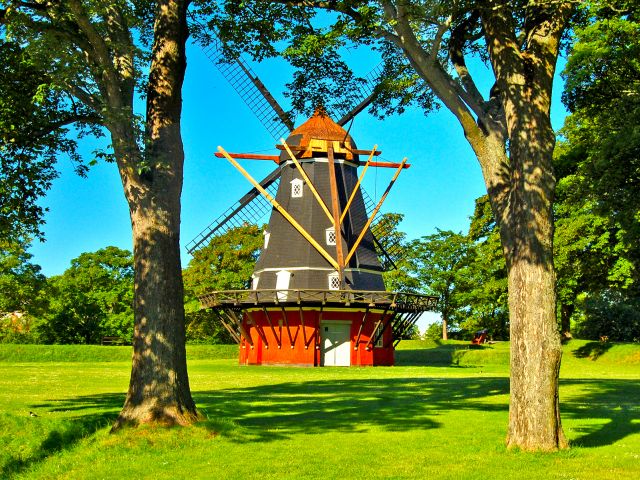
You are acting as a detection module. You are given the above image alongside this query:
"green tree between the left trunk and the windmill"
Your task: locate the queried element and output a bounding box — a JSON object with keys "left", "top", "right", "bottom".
{"left": 183, "top": 225, "right": 263, "bottom": 343}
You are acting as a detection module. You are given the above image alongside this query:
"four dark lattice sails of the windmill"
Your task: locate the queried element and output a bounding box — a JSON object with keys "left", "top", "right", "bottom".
{"left": 186, "top": 30, "right": 402, "bottom": 269}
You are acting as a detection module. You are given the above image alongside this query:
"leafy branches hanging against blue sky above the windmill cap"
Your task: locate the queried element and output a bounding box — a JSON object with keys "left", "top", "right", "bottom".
{"left": 200, "top": 0, "right": 442, "bottom": 117}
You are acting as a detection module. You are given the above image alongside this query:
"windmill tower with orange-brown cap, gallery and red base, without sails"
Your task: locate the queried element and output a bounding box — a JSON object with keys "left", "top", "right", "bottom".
{"left": 200, "top": 110, "right": 437, "bottom": 366}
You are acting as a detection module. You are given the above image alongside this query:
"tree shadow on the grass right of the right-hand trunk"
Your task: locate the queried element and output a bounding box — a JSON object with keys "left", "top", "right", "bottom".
{"left": 560, "top": 379, "right": 640, "bottom": 448}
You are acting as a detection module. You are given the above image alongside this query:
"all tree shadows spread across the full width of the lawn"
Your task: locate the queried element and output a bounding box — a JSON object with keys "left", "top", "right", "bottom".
{"left": 12, "top": 376, "right": 640, "bottom": 460}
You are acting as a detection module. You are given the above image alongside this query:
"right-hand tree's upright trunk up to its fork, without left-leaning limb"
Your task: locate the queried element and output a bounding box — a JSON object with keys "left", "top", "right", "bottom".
{"left": 481, "top": 2, "right": 569, "bottom": 451}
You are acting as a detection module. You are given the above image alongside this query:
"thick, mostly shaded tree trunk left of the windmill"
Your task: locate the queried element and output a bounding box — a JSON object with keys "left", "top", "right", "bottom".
{"left": 112, "top": 0, "right": 197, "bottom": 429}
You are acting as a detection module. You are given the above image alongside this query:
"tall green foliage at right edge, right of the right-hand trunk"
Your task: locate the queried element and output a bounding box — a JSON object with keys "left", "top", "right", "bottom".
{"left": 557, "top": 2, "right": 640, "bottom": 288}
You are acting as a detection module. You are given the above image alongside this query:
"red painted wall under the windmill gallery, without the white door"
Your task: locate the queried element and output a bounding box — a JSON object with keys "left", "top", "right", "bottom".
{"left": 240, "top": 310, "right": 394, "bottom": 366}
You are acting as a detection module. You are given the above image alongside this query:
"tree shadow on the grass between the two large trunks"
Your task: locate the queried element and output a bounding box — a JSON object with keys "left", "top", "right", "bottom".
{"left": 195, "top": 377, "right": 509, "bottom": 442}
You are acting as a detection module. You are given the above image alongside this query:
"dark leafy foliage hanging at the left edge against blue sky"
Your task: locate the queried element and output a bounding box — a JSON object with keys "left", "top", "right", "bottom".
{"left": 0, "top": 37, "right": 83, "bottom": 241}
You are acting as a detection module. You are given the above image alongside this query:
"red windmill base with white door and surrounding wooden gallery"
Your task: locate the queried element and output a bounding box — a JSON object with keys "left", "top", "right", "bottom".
{"left": 201, "top": 290, "right": 437, "bottom": 367}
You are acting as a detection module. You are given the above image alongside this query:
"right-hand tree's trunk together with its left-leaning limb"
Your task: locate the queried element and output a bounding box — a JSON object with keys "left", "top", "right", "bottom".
{"left": 372, "top": 0, "right": 572, "bottom": 450}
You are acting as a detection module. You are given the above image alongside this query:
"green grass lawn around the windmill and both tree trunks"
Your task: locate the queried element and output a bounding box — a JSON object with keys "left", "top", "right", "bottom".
{"left": 0, "top": 341, "right": 640, "bottom": 480}
